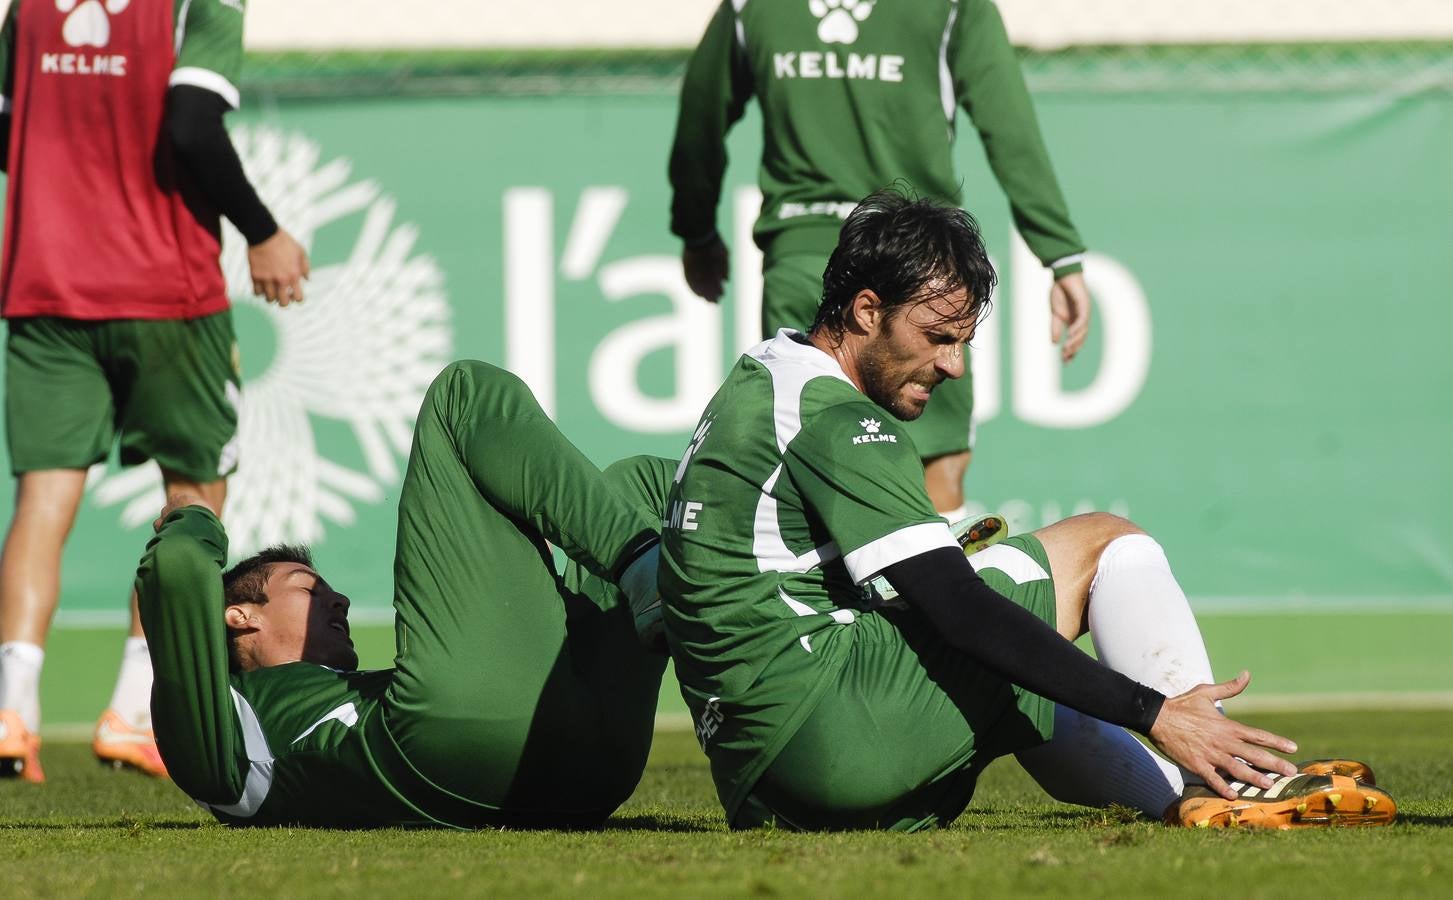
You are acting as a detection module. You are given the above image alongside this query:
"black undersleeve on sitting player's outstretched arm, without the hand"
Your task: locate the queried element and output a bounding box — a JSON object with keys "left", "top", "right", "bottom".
{"left": 883, "top": 548, "right": 1165, "bottom": 734}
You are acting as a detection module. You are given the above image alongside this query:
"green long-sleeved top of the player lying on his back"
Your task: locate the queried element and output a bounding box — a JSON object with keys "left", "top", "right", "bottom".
{"left": 137, "top": 506, "right": 443, "bottom": 827}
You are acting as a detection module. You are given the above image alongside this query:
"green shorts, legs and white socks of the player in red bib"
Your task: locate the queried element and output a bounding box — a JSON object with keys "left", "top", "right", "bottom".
{"left": 0, "top": 313, "right": 237, "bottom": 779}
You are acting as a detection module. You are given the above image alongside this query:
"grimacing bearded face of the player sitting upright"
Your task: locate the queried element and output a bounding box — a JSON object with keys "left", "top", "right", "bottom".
{"left": 857, "top": 288, "right": 975, "bottom": 422}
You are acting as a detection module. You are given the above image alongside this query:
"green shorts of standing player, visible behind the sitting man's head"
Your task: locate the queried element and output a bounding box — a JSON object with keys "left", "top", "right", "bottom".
{"left": 761, "top": 253, "right": 974, "bottom": 459}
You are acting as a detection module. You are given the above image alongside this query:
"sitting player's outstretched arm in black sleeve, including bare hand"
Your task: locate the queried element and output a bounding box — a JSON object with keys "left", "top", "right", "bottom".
{"left": 883, "top": 548, "right": 1296, "bottom": 800}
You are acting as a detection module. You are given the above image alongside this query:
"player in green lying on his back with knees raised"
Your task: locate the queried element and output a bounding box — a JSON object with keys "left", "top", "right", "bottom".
{"left": 137, "top": 362, "right": 671, "bottom": 827}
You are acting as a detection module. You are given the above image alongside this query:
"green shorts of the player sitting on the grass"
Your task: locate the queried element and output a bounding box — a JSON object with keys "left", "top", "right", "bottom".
{"left": 731, "top": 535, "right": 1055, "bottom": 830}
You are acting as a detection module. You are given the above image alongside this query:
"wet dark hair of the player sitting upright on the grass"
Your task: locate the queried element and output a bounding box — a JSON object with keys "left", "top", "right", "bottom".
{"left": 812, "top": 185, "right": 998, "bottom": 337}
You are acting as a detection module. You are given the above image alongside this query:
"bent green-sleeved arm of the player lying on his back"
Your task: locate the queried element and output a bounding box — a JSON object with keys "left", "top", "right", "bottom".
{"left": 137, "top": 506, "right": 246, "bottom": 803}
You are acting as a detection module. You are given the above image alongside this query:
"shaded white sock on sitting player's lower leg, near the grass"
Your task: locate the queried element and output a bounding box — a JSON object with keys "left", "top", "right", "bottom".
{"left": 1014, "top": 707, "right": 1186, "bottom": 819}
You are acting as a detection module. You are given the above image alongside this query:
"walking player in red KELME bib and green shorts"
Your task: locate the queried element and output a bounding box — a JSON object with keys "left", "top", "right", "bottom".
{"left": 0, "top": 0, "right": 308, "bottom": 782}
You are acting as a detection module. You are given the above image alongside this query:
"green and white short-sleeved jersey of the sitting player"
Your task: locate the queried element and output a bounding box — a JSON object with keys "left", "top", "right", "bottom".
{"left": 660, "top": 332, "right": 956, "bottom": 820}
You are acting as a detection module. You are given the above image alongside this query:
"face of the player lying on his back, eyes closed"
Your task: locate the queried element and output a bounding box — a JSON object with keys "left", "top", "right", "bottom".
{"left": 230, "top": 563, "right": 359, "bottom": 669}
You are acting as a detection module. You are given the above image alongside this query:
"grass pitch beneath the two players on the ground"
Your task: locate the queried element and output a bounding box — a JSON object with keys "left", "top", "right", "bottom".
{"left": 0, "top": 710, "right": 1453, "bottom": 900}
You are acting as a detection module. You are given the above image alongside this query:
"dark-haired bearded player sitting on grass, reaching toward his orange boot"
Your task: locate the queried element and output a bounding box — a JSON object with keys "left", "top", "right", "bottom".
{"left": 660, "top": 192, "right": 1393, "bottom": 829}
